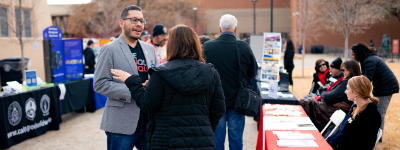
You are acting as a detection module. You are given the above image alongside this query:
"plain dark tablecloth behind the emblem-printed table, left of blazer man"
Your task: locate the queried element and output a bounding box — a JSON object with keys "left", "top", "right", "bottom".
{"left": 59, "top": 79, "right": 95, "bottom": 115}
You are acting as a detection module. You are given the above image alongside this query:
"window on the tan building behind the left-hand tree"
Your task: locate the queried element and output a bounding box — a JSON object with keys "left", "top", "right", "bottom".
{"left": 15, "top": 8, "right": 32, "bottom": 37}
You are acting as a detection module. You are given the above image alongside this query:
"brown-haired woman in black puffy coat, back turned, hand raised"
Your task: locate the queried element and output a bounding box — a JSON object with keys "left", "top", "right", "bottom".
{"left": 111, "top": 25, "right": 225, "bottom": 150}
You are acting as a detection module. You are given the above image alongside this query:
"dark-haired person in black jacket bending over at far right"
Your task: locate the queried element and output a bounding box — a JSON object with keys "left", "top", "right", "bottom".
{"left": 351, "top": 43, "right": 399, "bottom": 139}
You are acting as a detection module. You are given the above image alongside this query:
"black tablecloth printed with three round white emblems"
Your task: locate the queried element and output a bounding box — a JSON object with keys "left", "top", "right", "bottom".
{"left": 0, "top": 87, "right": 61, "bottom": 149}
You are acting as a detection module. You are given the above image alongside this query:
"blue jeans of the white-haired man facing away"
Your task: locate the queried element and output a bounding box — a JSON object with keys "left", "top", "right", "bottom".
{"left": 214, "top": 110, "right": 245, "bottom": 150}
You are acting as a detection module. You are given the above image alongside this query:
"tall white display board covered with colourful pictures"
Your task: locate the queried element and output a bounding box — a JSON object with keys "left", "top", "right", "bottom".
{"left": 261, "top": 32, "right": 282, "bottom": 81}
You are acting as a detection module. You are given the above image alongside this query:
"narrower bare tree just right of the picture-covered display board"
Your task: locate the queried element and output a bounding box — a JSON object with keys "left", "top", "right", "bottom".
{"left": 294, "top": 0, "right": 321, "bottom": 78}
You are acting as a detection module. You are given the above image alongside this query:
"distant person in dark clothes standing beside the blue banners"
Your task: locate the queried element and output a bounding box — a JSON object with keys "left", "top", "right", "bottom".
{"left": 83, "top": 40, "right": 96, "bottom": 74}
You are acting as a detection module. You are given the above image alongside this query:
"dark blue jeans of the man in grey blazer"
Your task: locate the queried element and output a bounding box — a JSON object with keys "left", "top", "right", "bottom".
{"left": 106, "top": 126, "right": 147, "bottom": 150}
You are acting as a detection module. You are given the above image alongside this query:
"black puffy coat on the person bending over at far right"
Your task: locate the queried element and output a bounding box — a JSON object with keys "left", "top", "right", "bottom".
{"left": 360, "top": 51, "right": 399, "bottom": 96}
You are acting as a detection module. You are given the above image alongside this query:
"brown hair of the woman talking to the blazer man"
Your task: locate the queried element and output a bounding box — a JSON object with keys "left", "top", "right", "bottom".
{"left": 167, "top": 24, "right": 206, "bottom": 63}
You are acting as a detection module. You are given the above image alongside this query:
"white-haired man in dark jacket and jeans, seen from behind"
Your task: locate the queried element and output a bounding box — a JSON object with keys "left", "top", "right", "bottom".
{"left": 203, "top": 15, "right": 258, "bottom": 150}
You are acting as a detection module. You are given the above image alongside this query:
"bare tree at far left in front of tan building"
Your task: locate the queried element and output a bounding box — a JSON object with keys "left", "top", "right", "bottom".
{"left": 0, "top": 0, "right": 41, "bottom": 81}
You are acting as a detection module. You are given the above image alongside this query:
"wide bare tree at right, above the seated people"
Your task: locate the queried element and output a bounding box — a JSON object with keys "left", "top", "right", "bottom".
{"left": 320, "top": 0, "right": 385, "bottom": 60}
